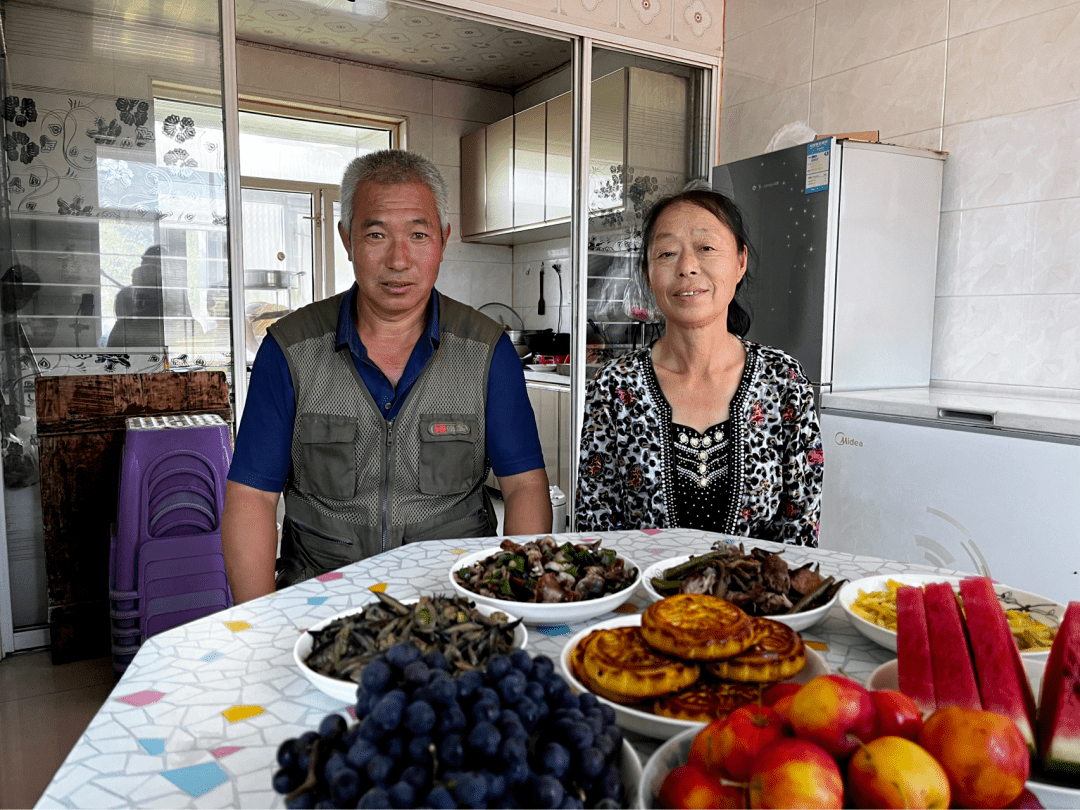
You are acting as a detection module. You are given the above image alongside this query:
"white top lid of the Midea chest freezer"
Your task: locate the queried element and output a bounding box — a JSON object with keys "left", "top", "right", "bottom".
{"left": 821, "top": 387, "right": 1080, "bottom": 437}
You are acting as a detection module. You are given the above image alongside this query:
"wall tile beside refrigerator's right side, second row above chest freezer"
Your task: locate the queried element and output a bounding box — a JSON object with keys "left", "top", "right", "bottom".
{"left": 937, "top": 203, "right": 1036, "bottom": 296}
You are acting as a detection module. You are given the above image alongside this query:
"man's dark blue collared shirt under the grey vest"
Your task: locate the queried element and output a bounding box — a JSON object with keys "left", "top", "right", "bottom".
{"left": 229, "top": 284, "right": 544, "bottom": 492}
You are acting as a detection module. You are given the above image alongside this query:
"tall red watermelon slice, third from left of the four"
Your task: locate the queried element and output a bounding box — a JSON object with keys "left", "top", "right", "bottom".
{"left": 960, "top": 577, "right": 1038, "bottom": 756}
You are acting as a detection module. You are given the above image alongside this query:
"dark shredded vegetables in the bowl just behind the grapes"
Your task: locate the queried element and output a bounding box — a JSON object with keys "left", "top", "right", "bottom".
{"left": 303, "top": 593, "right": 521, "bottom": 683}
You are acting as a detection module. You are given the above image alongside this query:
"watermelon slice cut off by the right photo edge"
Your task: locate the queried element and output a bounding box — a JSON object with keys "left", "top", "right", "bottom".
{"left": 1039, "top": 602, "right": 1080, "bottom": 773}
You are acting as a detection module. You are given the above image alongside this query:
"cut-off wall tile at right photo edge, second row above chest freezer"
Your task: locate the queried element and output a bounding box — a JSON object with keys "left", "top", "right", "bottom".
{"left": 1030, "top": 198, "right": 1080, "bottom": 295}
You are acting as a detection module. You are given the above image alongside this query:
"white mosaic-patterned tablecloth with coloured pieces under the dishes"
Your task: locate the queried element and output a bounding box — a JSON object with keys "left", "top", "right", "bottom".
{"left": 37, "top": 529, "right": 967, "bottom": 808}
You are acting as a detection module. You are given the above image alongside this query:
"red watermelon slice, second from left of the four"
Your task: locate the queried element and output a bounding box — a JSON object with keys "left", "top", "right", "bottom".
{"left": 926, "top": 582, "right": 983, "bottom": 710}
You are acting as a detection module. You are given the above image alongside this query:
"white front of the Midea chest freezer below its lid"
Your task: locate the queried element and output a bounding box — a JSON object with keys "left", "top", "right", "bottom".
{"left": 819, "top": 401, "right": 1080, "bottom": 604}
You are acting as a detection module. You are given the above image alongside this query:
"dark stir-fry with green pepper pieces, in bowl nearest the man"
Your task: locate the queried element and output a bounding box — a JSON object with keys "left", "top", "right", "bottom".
{"left": 454, "top": 535, "right": 637, "bottom": 604}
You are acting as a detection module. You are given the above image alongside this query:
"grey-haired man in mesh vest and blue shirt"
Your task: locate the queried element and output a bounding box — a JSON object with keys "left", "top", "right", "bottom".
{"left": 221, "top": 150, "right": 551, "bottom": 603}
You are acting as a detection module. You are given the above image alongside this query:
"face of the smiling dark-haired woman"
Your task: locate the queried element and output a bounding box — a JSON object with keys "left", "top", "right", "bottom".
{"left": 648, "top": 202, "right": 746, "bottom": 330}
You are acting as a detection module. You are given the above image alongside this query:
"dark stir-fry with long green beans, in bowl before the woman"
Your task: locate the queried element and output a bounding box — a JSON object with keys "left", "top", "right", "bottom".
{"left": 650, "top": 542, "right": 847, "bottom": 616}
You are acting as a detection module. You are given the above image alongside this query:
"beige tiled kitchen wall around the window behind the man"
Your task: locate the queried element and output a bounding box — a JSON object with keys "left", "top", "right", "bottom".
{"left": 237, "top": 43, "right": 513, "bottom": 313}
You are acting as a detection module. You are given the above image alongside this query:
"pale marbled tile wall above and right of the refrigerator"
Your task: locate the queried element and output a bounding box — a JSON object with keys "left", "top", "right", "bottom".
{"left": 720, "top": 0, "right": 1080, "bottom": 397}
